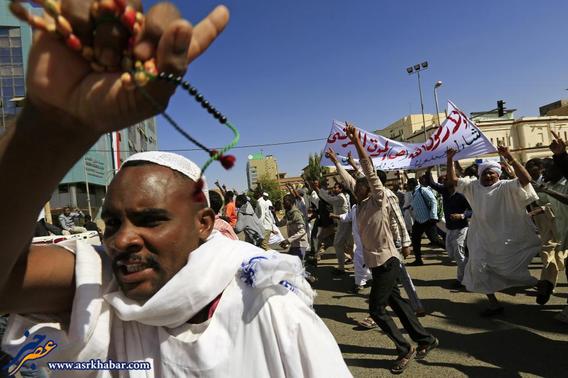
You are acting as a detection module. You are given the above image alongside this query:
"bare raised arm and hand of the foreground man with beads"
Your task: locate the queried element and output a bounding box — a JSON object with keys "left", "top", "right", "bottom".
{"left": 0, "top": 3, "right": 228, "bottom": 312}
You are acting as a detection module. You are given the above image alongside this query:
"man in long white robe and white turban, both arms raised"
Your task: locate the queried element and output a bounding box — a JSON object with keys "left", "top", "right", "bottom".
{"left": 447, "top": 146, "right": 540, "bottom": 316}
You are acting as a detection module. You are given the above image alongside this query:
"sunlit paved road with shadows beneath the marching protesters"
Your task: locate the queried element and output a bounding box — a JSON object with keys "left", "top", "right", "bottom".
{"left": 306, "top": 244, "right": 568, "bottom": 377}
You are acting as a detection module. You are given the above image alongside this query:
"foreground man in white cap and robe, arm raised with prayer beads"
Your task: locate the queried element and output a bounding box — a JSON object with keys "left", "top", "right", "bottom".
{"left": 0, "top": 4, "right": 350, "bottom": 377}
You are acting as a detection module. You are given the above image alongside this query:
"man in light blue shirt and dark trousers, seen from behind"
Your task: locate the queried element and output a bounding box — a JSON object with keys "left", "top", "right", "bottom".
{"left": 407, "top": 178, "right": 444, "bottom": 266}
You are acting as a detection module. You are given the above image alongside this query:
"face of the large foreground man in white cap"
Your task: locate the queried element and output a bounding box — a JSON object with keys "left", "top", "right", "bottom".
{"left": 102, "top": 164, "right": 215, "bottom": 301}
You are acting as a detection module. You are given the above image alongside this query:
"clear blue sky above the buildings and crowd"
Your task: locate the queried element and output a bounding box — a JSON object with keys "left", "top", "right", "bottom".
{"left": 143, "top": 0, "right": 568, "bottom": 191}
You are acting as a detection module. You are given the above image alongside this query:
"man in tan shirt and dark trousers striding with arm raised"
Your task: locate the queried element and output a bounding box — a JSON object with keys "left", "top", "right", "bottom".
{"left": 345, "top": 124, "right": 438, "bottom": 374}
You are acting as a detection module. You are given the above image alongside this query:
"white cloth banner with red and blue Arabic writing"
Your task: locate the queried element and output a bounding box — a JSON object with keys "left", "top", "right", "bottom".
{"left": 321, "top": 101, "right": 497, "bottom": 171}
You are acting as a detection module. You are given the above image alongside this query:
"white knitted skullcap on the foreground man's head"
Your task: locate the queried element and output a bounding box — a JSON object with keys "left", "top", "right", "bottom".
{"left": 124, "top": 151, "right": 209, "bottom": 205}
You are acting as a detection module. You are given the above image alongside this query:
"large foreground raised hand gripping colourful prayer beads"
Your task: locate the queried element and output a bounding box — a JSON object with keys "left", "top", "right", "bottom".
{"left": 26, "top": 1, "right": 229, "bottom": 135}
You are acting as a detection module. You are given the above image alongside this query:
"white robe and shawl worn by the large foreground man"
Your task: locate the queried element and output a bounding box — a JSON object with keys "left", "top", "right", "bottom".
{"left": 3, "top": 232, "right": 351, "bottom": 378}
